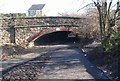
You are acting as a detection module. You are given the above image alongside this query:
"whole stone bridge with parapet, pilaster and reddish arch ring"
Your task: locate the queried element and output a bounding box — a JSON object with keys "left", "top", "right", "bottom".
{"left": 0, "top": 17, "right": 83, "bottom": 47}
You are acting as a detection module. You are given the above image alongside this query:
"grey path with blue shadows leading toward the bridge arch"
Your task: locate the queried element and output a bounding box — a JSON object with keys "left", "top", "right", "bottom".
{"left": 4, "top": 47, "right": 108, "bottom": 80}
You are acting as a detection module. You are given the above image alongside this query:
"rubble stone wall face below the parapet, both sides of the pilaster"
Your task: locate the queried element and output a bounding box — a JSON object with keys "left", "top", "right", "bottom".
{"left": 0, "top": 27, "right": 77, "bottom": 47}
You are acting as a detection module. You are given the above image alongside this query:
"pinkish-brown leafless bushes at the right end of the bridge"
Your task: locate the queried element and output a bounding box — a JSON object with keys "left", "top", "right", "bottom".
{"left": 59, "top": 8, "right": 100, "bottom": 40}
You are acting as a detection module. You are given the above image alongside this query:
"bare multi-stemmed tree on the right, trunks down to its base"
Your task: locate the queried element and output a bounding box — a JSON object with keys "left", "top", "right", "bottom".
{"left": 93, "top": 0, "right": 119, "bottom": 51}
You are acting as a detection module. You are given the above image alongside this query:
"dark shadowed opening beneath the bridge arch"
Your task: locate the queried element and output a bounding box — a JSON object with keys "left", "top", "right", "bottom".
{"left": 34, "top": 31, "right": 78, "bottom": 46}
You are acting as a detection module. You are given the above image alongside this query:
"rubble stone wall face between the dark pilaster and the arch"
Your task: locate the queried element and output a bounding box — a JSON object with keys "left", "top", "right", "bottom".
{"left": 16, "top": 27, "right": 58, "bottom": 47}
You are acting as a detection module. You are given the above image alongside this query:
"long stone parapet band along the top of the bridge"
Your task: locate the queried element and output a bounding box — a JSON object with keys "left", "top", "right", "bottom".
{"left": 2, "top": 17, "right": 83, "bottom": 27}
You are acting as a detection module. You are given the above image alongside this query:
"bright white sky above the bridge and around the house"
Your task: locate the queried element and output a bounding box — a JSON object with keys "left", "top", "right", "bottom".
{"left": 0, "top": 0, "right": 118, "bottom": 16}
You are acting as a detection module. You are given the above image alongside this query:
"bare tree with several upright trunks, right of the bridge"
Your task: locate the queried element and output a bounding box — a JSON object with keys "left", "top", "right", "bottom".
{"left": 92, "top": 0, "right": 119, "bottom": 47}
